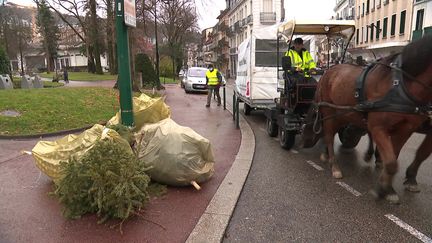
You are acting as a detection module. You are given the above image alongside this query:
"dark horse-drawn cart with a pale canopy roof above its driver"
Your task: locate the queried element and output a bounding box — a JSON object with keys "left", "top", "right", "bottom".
{"left": 265, "top": 20, "right": 360, "bottom": 149}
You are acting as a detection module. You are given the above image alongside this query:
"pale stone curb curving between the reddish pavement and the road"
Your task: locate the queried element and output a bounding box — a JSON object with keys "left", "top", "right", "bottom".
{"left": 186, "top": 103, "right": 255, "bottom": 243}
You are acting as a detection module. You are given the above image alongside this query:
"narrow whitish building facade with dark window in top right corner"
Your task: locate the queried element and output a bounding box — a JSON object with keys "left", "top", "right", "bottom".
{"left": 411, "top": 0, "right": 432, "bottom": 40}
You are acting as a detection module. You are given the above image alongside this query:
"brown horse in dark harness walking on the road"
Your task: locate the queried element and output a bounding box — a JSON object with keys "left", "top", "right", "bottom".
{"left": 303, "top": 36, "right": 432, "bottom": 203}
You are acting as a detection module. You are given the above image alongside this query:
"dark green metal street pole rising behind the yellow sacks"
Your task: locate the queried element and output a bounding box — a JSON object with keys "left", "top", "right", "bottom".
{"left": 115, "top": 0, "right": 134, "bottom": 127}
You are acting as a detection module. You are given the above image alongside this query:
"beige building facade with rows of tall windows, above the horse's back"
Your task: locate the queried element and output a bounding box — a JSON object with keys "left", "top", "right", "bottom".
{"left": 355, "top": 0, "right": 413, "bottom": 61}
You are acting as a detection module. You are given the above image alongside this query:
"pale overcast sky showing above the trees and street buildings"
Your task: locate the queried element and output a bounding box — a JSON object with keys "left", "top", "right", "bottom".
{"left": 8, "top": 0, "right": 336, "bottom": 29}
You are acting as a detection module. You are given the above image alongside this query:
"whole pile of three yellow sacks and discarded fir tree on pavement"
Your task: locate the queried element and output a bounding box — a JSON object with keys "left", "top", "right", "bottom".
{"left": 32, "top": 94, "right": 214, "bottom": 220}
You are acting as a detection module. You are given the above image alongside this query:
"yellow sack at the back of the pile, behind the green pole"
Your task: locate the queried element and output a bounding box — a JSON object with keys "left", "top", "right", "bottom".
{"left": 107, "top": 94, "right": 171, "bottom": 131}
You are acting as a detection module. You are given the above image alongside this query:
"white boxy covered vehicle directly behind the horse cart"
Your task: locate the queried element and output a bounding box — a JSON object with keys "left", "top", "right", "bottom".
{"left": 235, "top": 25, "right": 286, "bottom": 115}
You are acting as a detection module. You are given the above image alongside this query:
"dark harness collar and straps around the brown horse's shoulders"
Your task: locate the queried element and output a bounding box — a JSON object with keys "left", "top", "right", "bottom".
{"left": 354, "top": 54, "right": 431, "bottom": 115}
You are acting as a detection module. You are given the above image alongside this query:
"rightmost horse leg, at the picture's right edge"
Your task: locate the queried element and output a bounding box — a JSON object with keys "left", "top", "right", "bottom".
{"left": 404, "top": 131, "right": 432, "bottom": 192}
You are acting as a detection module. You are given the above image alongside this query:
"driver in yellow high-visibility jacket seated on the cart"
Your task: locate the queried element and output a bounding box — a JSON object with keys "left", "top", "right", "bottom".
{"left": 285, "top": 38, "right": 316, "bottom": 77}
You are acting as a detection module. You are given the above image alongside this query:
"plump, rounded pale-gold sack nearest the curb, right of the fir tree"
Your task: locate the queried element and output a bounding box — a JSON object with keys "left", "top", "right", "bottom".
{"left": 135, "top": 118, "right": 214, "bottom": 186}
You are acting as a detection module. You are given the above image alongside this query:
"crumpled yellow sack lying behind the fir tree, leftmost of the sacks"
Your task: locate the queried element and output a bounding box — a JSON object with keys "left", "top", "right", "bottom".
{"left": 32, "top": 124, "right": 132, "bottom": 181}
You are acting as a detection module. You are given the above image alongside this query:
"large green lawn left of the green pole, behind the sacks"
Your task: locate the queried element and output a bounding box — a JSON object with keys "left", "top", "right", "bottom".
{"left": 0, "top": 88, "right": 119, "bottom": 135}
